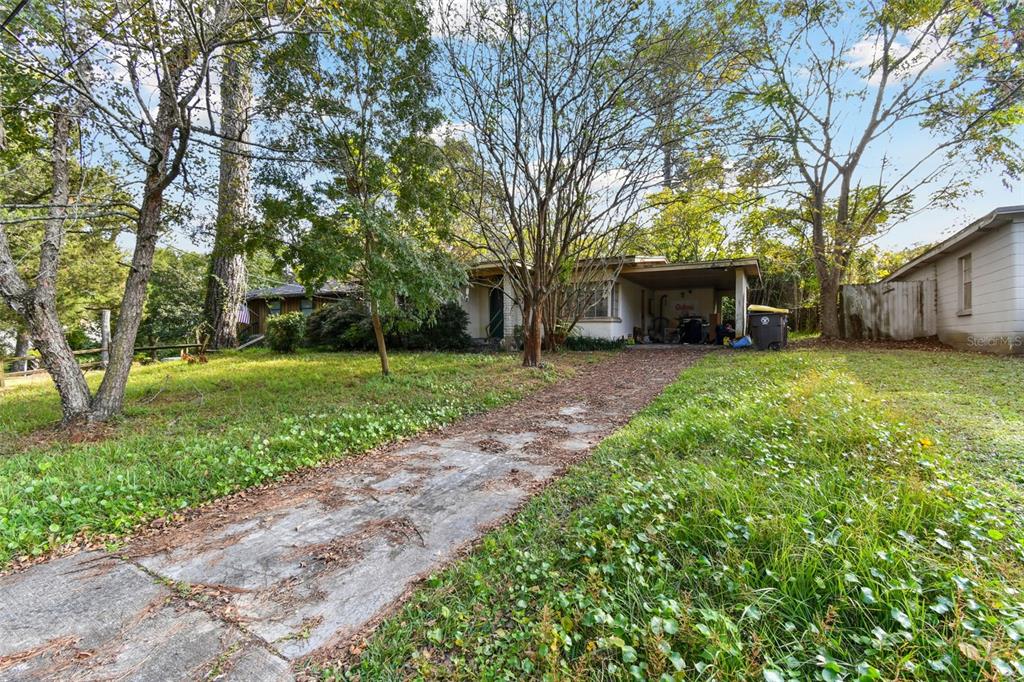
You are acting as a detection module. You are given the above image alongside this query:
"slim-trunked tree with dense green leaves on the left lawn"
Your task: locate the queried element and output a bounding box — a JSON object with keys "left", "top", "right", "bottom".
{"left": 261, "top": 0, "right": 465, "bottom": 375}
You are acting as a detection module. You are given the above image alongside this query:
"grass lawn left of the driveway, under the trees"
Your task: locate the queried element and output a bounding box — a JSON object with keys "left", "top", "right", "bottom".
{"left": 0, "top": 351, "right": 592, "bottom": 568}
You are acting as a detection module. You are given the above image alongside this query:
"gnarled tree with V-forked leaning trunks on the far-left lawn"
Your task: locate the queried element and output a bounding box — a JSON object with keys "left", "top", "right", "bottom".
{"left": 0, "top": 0, "right": 303, "bottom": 423}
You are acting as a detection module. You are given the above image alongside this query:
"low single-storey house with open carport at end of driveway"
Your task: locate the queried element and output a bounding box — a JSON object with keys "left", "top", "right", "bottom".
{"left": 462, "top": 256, "right": 760, "bottom": 340}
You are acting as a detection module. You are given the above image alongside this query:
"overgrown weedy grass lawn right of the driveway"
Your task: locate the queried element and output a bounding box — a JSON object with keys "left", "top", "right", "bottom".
{"left": 344, "top": 349, "right": 1024, "bottom": 682}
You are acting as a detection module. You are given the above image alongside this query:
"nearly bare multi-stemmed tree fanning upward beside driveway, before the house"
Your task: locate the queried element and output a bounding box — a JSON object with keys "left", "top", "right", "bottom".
{"left": 435, "top": 0, "right": 745, "bottom": 367}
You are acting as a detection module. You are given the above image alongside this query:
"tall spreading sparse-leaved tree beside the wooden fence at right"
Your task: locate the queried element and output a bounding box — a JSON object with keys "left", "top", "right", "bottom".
{"left": 744, "top": 0, "right": 1024, "bottom": 336}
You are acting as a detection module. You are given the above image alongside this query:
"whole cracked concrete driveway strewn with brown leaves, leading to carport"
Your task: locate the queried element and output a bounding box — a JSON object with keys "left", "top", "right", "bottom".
{"left": 0, "top": 349, "right": 701, "bottom": 680}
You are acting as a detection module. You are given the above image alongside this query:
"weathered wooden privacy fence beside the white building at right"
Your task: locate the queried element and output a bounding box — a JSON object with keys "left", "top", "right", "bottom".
{"left": 840, "top": 280, "right": 938, "bottom": 341}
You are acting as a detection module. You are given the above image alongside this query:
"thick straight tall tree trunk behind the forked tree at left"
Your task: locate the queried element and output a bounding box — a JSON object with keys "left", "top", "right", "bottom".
{"left": 205, "top": 48, "right": 253, "bottom": 348}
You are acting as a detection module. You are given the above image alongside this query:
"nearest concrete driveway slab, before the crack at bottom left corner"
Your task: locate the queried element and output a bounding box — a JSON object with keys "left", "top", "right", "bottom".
{"left": 0, "top": 552, "right": 289, "bottom": 680}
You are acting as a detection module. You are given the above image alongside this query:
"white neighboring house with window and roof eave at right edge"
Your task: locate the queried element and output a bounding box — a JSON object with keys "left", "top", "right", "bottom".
{"left": 883, "top": 206, "right": 1024, "bottom": 353}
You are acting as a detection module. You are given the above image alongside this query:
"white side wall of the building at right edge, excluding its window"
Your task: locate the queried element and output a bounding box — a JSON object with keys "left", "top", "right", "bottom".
{"left": 900, "top": 220, "right": 1024, "bottom": 353}
